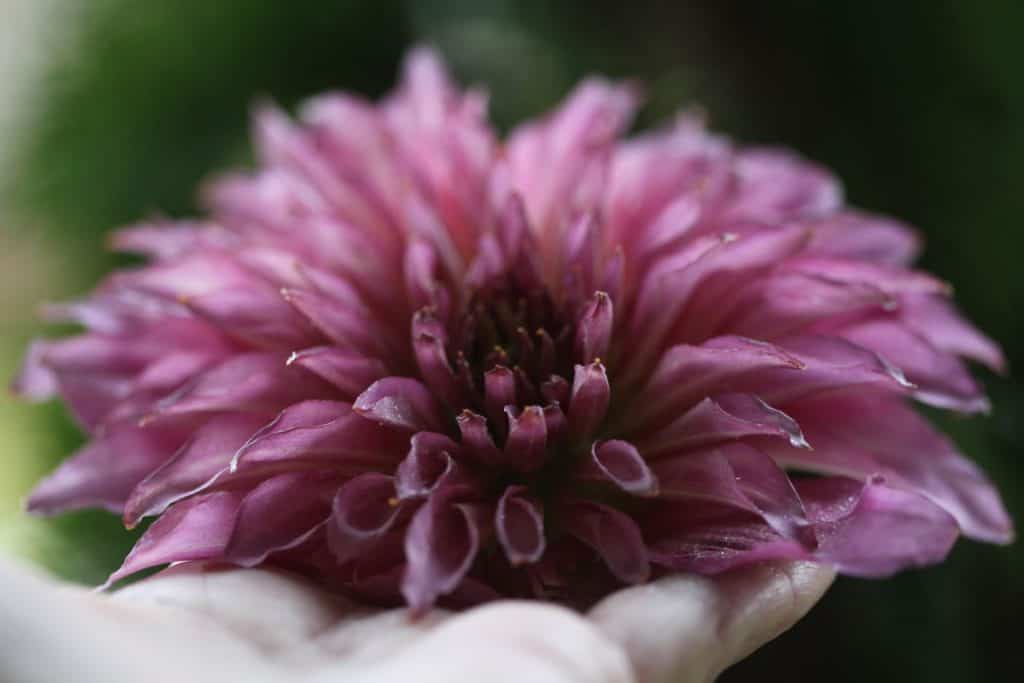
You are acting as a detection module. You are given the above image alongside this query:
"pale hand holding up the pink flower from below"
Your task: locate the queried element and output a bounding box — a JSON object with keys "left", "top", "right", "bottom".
{"left": 0, "top": 558, "right": 834, "bottom": 683}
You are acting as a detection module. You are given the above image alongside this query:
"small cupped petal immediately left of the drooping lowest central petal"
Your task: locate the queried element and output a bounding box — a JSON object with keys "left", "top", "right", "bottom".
{"left": 327, "top": 472, "right": 401, "bottom": 563}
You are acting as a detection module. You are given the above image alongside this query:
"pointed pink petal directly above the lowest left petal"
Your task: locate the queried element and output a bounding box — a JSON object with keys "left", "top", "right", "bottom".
{"left": 124, "top": 414, "right": 266, "bottom": 526}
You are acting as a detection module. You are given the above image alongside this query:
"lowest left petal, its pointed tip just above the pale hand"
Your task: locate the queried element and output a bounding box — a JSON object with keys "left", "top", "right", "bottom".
{"left": 106, "top": 490, "right": 244, "bottom": 586}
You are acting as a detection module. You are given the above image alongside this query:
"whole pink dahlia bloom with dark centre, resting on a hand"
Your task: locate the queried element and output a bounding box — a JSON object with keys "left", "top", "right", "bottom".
{"left": 17, "top": 50, "right": 1012, "bottom": 610}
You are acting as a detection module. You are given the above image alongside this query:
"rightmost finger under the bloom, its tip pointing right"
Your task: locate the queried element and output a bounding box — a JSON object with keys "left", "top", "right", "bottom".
{"left": 590, "top": 562, "right": 835, "bottom": 683}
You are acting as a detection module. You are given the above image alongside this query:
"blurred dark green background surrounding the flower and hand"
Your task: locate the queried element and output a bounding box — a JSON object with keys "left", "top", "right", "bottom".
{"left": 0, "top": 0, "right": 1024, "bottom": 682}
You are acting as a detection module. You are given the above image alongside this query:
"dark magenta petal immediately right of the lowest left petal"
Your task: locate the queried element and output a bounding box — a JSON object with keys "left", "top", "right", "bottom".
{"left": 224, "top": 472, "right": 339, "bottom": 566}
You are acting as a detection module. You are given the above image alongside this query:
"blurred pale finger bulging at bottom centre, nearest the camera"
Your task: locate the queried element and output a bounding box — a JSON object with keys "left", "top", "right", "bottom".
{"left": 315, "top": 601, "right": 635, "bottom": 683}
